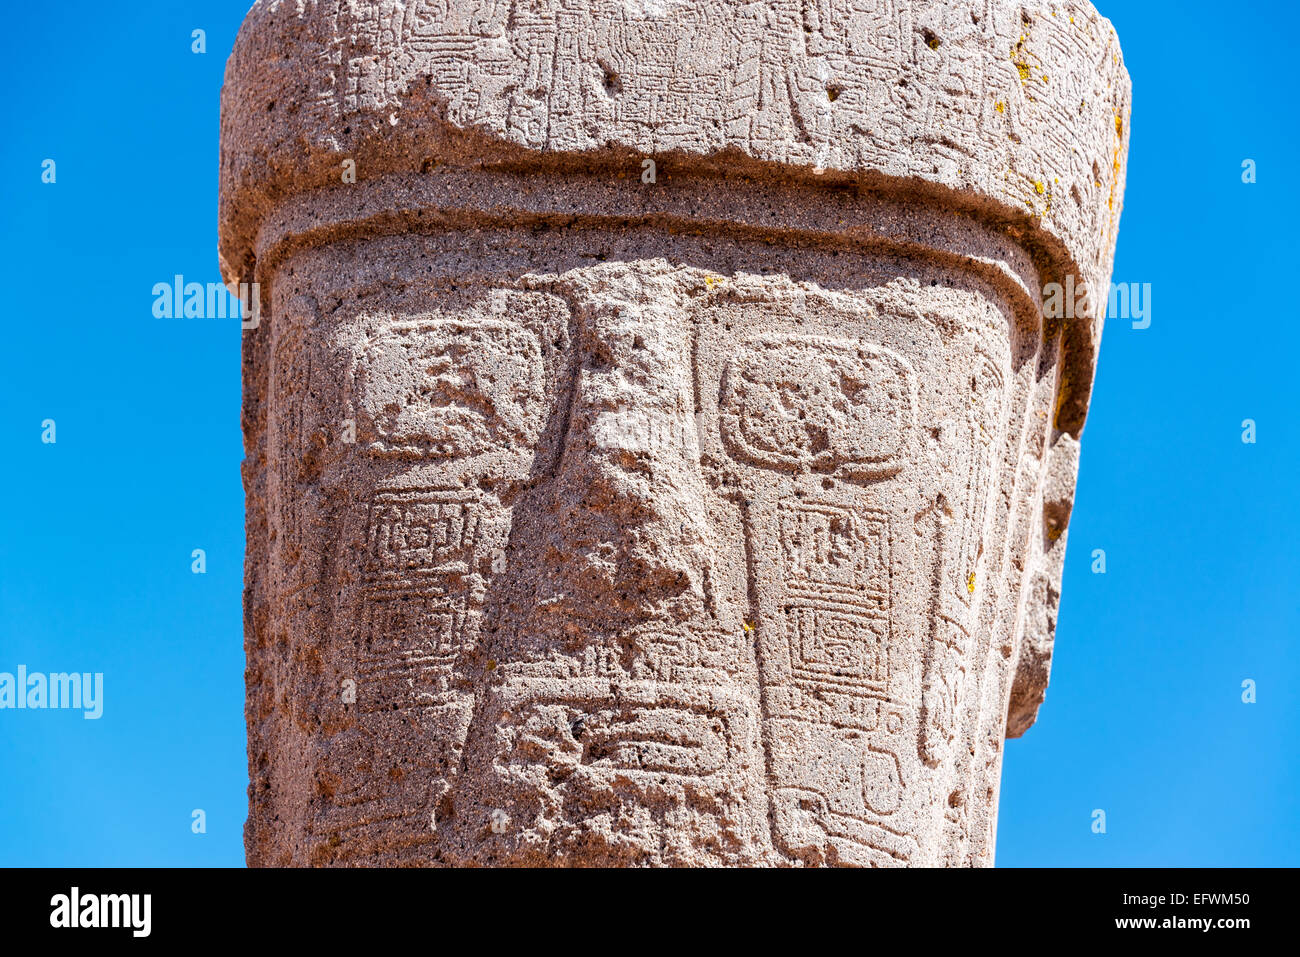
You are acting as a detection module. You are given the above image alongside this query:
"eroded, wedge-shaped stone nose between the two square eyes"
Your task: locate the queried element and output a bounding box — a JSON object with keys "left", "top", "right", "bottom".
{"left": 527, "top": 303, "right": 709, "bottom": 625}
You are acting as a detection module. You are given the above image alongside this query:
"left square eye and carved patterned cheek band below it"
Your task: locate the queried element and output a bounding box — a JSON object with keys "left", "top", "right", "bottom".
{"left": 309, "top": 290, "right": 569, "bottom": 861}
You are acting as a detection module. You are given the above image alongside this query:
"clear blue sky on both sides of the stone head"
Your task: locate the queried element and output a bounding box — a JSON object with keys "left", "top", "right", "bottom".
{"left": 0, "top": 0, "right": 1300, "bottom": 866}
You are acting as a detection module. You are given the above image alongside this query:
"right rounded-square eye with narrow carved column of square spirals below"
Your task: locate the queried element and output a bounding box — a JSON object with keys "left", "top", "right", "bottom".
{"left": 718, "top": 327, "right": 919, "bottom": 866}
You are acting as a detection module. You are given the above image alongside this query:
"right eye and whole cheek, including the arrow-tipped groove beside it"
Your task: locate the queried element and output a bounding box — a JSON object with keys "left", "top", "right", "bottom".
{"left": 702, "top": 302, "right": 1006, "bottom": 866}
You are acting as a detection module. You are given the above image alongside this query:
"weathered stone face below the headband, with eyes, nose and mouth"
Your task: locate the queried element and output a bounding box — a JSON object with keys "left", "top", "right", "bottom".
{"left": 267, "top": 230, "right": 1054, "bottom": 866}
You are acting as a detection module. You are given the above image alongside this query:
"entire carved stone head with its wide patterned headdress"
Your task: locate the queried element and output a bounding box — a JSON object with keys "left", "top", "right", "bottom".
{"left": 221, "top": 0, "right": 1128, "bottom": 866}
